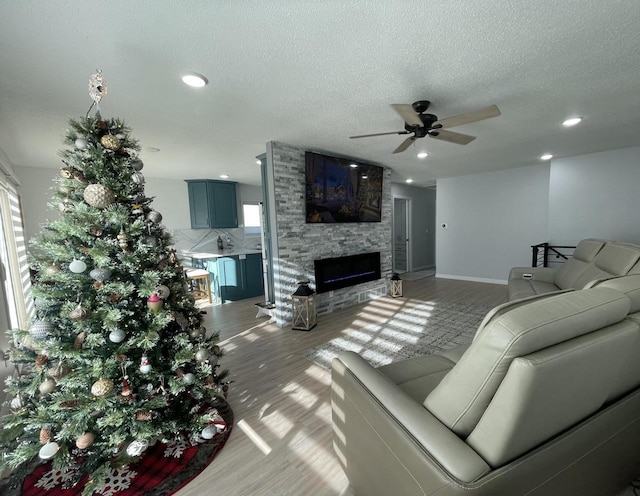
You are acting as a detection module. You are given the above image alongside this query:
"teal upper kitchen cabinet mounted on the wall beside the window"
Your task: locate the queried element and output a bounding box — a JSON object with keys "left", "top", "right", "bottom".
{"left": 186, "top": 179, "right": 238, "bottom": 229}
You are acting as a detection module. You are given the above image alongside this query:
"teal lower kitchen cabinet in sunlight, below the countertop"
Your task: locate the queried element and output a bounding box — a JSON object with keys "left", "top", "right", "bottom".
{"left": 207, "top": 253, "right": 264, "bottom": 303}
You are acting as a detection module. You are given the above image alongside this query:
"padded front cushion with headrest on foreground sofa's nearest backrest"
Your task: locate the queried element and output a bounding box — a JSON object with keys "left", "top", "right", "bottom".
{"left": 424, "top": 288, "right": 629, "bottom": 436}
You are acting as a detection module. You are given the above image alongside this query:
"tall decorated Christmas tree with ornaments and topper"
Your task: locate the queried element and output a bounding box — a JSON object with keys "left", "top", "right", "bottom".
{"left": 0, "top": 72, "right": 227, "bottom": 494}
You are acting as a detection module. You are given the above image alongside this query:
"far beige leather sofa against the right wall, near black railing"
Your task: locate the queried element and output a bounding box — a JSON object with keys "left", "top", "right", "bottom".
{"left": 507, "top": 238, "right": 640, "bottom": 300}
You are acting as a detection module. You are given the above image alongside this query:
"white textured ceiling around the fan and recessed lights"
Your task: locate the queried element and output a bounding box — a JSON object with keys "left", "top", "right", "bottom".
{"left": 0, "top": 0, "right": 640, "bottom": 185}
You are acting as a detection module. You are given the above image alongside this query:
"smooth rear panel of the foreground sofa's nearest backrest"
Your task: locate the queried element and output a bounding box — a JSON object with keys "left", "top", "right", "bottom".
{"left": 467, "top": 319, "right": 640, "bottom": 468}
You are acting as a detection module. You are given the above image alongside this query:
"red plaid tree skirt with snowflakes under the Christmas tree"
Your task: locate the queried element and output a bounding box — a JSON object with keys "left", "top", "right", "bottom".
{"left": 5, "top": 402, "right": 233, "bottom": 496}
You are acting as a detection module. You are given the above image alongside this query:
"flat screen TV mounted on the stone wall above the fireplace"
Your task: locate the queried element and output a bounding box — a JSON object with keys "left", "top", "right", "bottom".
{"left": 305, "top": 152, "right": 384, "bottom": 223}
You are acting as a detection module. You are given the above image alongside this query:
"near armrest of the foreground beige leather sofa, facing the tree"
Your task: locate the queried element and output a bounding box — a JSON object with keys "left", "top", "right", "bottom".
{"left": 331, "top": 352, "right": 490, "bottom": 488}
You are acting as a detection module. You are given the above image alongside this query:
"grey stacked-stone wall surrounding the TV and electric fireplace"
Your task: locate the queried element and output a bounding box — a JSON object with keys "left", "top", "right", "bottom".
{"left": 265, "top": 141, "right": 392, "bottom": 329}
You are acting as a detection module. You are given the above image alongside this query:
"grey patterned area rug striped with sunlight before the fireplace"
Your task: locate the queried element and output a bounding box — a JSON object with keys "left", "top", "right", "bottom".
{"left": 302, "top": 300, "right": 492, "bottom": 370}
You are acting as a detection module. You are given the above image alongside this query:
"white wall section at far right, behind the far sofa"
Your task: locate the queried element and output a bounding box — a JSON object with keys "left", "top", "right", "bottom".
{"left": 548, "top": 147, "right": 640, "bottom": 245}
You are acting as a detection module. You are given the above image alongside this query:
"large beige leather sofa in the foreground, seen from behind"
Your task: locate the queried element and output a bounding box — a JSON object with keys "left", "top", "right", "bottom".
{"left": 331, "top": 275, "right": 640, "bottom": 496}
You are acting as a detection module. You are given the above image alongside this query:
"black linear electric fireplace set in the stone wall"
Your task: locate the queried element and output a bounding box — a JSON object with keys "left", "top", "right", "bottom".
{"left": 313, "top": 251, "right": 380, "bottom": 293}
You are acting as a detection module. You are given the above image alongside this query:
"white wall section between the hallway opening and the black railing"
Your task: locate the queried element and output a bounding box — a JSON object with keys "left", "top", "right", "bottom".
{"left": 436, "top": 164, "right": 549, "bottom": 283}
